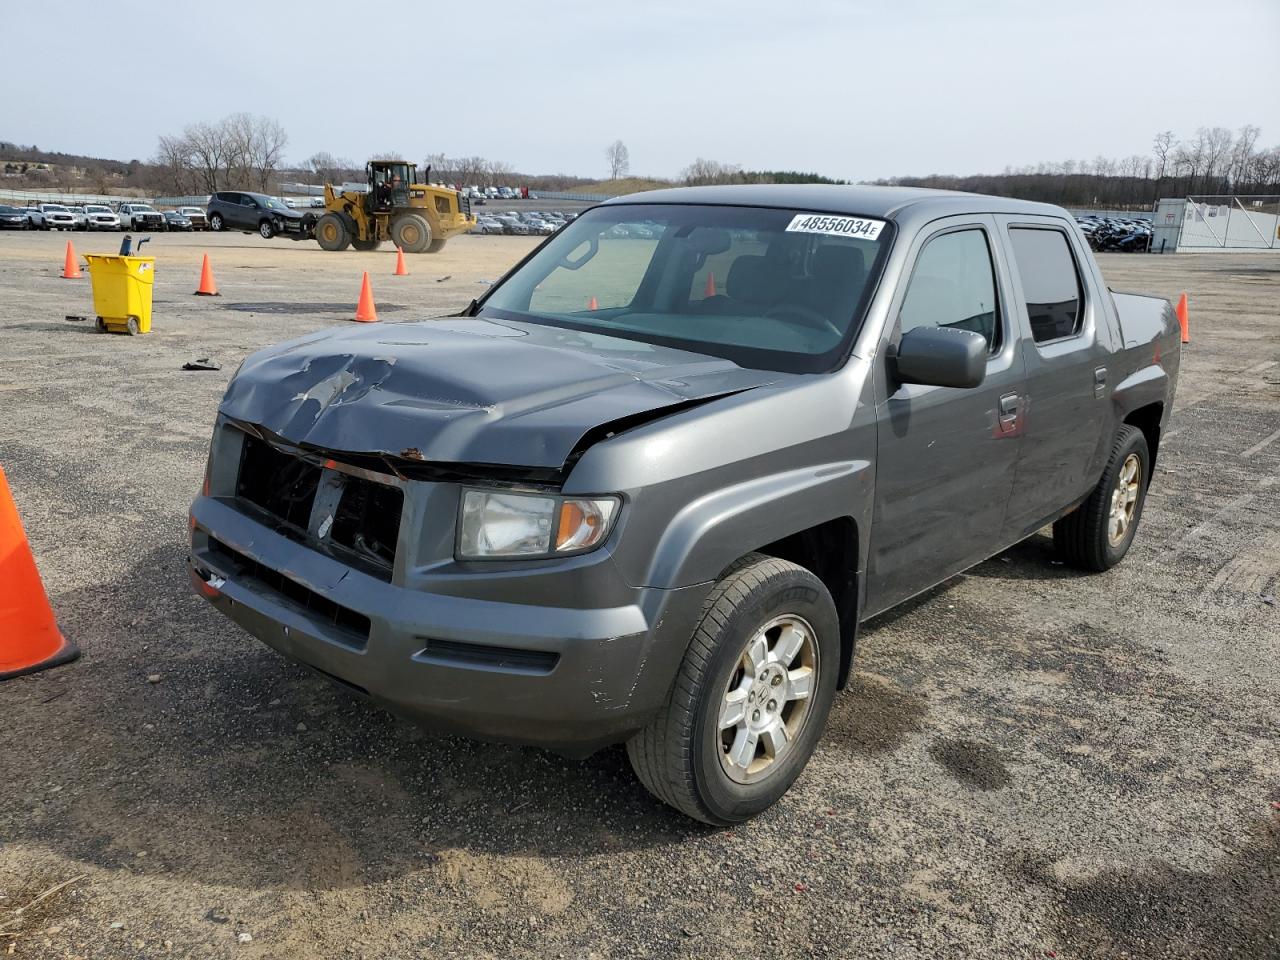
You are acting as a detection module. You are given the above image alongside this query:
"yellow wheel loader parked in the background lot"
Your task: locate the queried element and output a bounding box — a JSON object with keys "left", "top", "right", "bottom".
{"left": 315, "top": 160, "right": 475, "bottom": 253}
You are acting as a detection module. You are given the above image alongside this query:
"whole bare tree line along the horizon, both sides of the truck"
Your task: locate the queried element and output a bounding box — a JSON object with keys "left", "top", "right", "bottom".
{"left": 0, "top": 122, "right": 1280, "bottom": 210}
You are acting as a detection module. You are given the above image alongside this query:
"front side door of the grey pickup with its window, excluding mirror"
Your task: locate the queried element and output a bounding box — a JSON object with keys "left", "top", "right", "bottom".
{"left": 867, "top": 216, "right": 1023, "bottom": 614}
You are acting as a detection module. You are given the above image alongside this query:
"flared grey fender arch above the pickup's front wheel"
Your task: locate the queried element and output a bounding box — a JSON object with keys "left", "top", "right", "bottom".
{"left": 641, "top": 460, "right": 874, "bottom": 589}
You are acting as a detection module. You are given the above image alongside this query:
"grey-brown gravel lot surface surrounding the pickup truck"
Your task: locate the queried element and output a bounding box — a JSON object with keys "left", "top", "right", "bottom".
{"left": 0, "top": 233, "right": 1280, "bottom": 960}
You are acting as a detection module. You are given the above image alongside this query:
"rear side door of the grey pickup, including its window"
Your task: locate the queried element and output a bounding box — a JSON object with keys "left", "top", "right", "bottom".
{"left": 997, "top": 216, "right": 1115, "bottom": 543}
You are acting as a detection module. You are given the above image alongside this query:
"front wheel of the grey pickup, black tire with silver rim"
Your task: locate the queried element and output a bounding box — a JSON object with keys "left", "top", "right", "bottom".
{"left": 627, "top": 553, "right": 840, "bottom": 826}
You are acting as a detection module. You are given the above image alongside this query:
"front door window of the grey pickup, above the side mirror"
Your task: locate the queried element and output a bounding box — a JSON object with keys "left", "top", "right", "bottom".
{"left": 899, "top": 228, "right": 1000, "bottom": 353}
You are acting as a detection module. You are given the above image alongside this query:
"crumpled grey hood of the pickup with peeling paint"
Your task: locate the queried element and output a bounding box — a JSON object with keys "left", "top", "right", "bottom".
{"left": 220, "top": 317, "right": 787, "bottom": 468}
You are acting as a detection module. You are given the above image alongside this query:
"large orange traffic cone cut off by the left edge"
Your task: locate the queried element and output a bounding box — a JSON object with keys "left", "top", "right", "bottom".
{"left": 0, "top": 467, "right": 79, "bottom": 680}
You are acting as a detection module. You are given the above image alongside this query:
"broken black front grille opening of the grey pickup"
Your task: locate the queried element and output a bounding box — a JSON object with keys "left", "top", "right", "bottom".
{"left": 236, "top": 434, "right": 404, "bottom": 581}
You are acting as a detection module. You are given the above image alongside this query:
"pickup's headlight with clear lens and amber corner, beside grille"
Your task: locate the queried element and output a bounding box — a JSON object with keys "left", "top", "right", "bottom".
{"left": 458, "top": 490, "right": 618, "bottom": 559}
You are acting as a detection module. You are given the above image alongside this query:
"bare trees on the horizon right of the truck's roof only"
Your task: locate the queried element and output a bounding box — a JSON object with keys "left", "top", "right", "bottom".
{"left": 876, "top": 124, "right": 1280, "bottom": 210}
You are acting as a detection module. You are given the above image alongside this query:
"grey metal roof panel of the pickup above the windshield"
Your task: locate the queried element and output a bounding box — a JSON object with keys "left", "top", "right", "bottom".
{"left": 605, "top": 183, "right": 1066, "bottom": 220}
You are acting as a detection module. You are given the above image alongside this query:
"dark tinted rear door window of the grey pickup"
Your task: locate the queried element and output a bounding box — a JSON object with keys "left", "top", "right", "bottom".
{"left": 1009, "top": 228, "right": 1084, "bottom": 343}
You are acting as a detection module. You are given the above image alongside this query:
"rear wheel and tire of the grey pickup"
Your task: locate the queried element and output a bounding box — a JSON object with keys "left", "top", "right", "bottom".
{"left": 1053, "top": 424, "right": 1151, "bottom": 573}
